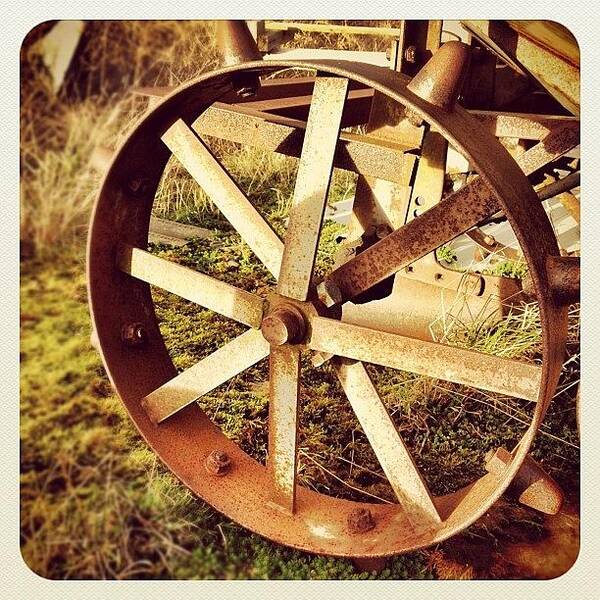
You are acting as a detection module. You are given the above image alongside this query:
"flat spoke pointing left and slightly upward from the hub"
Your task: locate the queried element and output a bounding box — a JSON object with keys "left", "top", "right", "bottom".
{"left": 117, "top": 246, "right": 264, "bottom": 329}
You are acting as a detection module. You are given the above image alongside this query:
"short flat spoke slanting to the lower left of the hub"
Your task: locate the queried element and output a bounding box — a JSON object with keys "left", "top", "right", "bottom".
{"left": 142, "top": 329, "right": 269, "bottom": 423}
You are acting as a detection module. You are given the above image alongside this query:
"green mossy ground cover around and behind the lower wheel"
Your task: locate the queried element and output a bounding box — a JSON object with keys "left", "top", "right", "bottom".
{"left": 21, "top": 233, "right": 578, "bottom": 579}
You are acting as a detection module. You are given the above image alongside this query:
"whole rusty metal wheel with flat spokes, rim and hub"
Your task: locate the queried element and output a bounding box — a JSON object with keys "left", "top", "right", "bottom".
{"left": 88, "top": 50, "right": 567, "bottom": 557}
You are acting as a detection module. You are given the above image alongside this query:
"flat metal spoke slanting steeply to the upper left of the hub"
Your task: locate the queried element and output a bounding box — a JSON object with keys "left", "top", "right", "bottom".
{"left": 161, "top": 119, "right": 283, "bottom": 278}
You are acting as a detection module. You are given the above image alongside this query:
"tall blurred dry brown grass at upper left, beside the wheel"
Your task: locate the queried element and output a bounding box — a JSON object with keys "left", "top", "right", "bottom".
{"left": 20, "top": 21, "right": 223, "bottom": 256}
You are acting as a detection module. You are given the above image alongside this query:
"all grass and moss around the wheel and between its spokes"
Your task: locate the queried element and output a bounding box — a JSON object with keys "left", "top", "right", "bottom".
{"left": 20, "top": 22, "right": 579, "bottom": 579}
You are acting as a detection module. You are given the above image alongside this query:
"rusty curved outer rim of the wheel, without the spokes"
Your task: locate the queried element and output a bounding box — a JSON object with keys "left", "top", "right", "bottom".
{"left": 88, "top": 61, "right": 567, "bottom": 557}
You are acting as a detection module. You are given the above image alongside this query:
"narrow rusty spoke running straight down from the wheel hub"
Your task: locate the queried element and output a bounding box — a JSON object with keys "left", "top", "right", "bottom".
{"left": 267, "top": 344, "right": 300, "bottom": 512}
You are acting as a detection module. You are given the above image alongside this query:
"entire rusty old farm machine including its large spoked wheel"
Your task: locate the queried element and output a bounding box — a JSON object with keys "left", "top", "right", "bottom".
{"left": 88, "top": 21, "right": 579, "bottom": 559}
